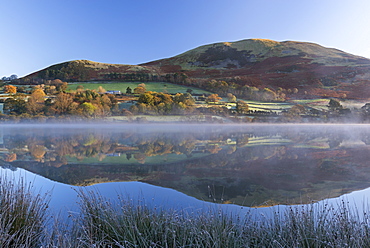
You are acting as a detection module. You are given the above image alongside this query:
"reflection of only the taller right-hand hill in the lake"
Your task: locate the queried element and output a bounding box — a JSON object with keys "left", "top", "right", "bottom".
{"left": 144, "top": 146, "right": 370, "bottom": 205}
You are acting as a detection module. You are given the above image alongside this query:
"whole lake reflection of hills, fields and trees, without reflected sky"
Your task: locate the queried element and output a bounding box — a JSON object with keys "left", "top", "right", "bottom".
{"left": 0, "top": 126, "right": 370, "bottom": 206}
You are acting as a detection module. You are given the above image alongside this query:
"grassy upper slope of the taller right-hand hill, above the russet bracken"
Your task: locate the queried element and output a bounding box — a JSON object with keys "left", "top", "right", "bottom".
{"left": 144, "top": 39, "right": 370, "bottom": 70}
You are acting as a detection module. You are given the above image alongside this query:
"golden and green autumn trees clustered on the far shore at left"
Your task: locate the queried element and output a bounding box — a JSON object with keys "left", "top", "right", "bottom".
{"left": 3, "top": 84, "right": 119, "bottom": 117}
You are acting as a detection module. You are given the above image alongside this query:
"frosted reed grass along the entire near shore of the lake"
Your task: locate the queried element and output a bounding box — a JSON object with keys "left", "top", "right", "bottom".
{"left": 0, "top": 180, "right": 370, "bottom": 248}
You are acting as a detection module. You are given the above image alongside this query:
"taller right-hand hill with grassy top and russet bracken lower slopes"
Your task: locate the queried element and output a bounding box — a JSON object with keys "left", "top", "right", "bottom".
{"left": 143, "top": 39, "right": 370, "bottom": 98}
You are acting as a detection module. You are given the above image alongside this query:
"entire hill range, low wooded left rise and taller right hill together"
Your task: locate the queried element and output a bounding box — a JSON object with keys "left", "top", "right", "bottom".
{"left": 23, "top": 39, "right": 370, "bottom": 99}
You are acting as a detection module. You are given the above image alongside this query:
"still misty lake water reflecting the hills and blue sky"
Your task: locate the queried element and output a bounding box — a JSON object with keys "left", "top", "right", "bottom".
{"left": 0, "top": 124, "right": 370, "bottom": 215}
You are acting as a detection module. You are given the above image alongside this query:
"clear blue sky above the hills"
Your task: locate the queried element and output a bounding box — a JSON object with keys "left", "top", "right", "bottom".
{"left": 0, "top": 0, "right": 370, "bottom": 77}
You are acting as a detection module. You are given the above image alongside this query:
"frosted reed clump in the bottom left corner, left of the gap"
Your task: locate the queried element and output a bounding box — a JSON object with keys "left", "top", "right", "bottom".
{"left": 0, "top": 177, "right": 48, "bottom": 247}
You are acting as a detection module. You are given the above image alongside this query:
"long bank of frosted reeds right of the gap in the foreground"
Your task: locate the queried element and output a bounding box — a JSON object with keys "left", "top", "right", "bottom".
{"left": 71, "top": 191, "right": 370, "bottom": 247}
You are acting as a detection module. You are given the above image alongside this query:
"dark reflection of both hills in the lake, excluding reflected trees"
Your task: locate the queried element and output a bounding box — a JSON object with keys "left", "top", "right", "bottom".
{"left": 6, "top": 140, "right": 370, "bottom": 205}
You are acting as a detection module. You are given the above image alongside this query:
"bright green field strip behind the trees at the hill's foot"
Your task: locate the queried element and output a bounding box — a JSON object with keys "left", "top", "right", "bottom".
{"left": 68, "top": 82, "right": 212, "bottom": 94}
